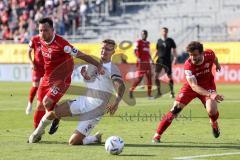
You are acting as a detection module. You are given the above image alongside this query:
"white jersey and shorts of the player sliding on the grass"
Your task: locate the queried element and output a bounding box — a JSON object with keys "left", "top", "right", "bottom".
{"left": 70, "top": 62, "right": 122, "bottom": 136}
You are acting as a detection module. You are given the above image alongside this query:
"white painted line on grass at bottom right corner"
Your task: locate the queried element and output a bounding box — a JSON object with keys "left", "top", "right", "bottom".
{"left": 173, "top": 152, "right": 240, "bottom": 160}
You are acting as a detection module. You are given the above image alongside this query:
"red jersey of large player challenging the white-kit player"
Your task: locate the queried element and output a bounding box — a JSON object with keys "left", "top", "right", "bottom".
{"left": 40, "top": 34, "right": 74, "bottom": 84}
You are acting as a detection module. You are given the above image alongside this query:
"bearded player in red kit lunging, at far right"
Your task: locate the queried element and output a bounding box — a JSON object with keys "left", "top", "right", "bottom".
{"left": 153, "top": 41, "right": 223, "bottom": 143}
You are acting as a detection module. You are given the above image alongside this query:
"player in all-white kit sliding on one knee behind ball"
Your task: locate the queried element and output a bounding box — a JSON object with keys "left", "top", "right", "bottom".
{"left": 29, "top": 39, "right": 125, "bottom": 145}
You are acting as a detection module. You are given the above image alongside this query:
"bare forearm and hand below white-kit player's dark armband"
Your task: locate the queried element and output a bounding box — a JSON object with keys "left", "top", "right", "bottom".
{"left": 107, "top": 79, "right": 125, "bottom": 115}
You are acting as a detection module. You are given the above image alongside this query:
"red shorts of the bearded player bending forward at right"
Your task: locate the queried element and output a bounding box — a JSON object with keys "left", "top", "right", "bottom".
{"left": 176, "top": 84, "right": 216, "bottom": 105}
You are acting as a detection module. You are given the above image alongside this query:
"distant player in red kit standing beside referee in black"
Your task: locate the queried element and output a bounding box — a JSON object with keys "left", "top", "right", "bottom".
{"left": 129, "top": 30, "right": 153, "bottom": 99}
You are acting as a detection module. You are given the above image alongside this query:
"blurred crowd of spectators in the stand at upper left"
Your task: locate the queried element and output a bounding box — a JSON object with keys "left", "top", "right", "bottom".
{"left": 0, "top": 0, "right": 119, "bottom": 43}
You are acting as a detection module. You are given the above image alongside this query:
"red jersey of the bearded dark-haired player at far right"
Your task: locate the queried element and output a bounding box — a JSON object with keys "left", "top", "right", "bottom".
{"left": 184, "top": 49, "right": 215, "bottom": 88}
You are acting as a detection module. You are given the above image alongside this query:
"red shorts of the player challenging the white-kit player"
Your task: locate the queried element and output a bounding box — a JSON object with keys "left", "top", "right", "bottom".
{"left": 37, "top": 81, "right": 70, "bottom": 110}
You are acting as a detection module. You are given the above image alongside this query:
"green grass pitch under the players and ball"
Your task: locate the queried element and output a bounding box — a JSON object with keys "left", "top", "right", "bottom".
{"left": 0, "top": 82, "right": 240, "bottom": 160}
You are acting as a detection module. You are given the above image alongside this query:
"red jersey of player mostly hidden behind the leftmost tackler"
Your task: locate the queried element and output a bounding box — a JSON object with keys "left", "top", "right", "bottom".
{"left": 29, "top": 35, "right": 44, "bottom": 71}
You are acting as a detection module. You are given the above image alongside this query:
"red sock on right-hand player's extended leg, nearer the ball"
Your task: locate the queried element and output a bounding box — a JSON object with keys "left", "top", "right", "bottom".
{"left": 157, "top": 112, "right": 176, "bottom": 135}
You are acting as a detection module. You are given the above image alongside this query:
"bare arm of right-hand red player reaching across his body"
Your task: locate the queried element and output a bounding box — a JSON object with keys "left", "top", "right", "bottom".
{"left": 186, "top": 76, "right": 223, "bottom": 103}
